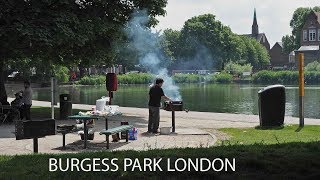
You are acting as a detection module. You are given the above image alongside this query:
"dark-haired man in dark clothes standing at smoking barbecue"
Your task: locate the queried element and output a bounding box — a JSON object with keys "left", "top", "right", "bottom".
{"left": 148, "top": 78, "right": 171, "bottom": 133}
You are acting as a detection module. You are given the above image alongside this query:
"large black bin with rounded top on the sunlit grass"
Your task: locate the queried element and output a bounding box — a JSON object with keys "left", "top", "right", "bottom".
{"left": 258, "top": 85, "right": 286, "bottom": 127}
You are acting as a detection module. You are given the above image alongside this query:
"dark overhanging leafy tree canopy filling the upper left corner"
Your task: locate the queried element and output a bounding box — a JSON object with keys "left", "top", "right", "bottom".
{"left": 0, "top": 0, "right": 167, "bottom": 103}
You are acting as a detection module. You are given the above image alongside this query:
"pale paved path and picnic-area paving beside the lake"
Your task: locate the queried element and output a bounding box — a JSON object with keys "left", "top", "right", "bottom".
{"left": 0, "top": 98, "right": 320, "bottom": 154}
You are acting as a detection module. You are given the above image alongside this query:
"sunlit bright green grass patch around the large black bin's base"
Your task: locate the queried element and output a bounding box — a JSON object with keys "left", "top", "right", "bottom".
{"left": 219, "top": 125, "right": 320, "bottom": 144}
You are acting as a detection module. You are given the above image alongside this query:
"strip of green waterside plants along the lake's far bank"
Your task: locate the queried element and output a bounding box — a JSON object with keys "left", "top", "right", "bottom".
{"left": 77, "top": 70, "right": 320, "bottom": 85}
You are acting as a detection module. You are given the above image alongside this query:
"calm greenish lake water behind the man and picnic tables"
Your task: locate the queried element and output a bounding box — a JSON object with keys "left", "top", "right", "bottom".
{"left": 17, "top": 84, "right": 320, "bottom": 118}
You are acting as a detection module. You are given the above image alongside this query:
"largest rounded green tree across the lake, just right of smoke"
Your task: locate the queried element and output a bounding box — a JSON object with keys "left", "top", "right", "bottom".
{"left": 181, "top": 14, "right": 242, "bottom": 69}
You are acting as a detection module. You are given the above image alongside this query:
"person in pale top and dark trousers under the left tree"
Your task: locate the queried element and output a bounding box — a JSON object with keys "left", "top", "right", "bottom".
{"left": 21, "top": 80, "right": 32, "bottom": 120}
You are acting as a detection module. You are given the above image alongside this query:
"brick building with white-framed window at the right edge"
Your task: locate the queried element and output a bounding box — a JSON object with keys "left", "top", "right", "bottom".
{"left": 295, "top": 11, "right": 320, "bottom": 65}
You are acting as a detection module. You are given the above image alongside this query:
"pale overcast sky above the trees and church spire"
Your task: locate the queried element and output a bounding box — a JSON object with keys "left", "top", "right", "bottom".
{"left": 155, "top": 0, "right": 320, "bottom": 47}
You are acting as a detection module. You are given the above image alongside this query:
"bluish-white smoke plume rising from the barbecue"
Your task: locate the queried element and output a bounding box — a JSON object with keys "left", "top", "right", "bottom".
{"left": 126, "top": 11, "right": 181, "bottom": 100}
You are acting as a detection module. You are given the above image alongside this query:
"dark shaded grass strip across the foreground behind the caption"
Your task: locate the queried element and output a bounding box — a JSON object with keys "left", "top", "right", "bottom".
{"left": 0, "top": 141, "right": 320, "bottom": 179}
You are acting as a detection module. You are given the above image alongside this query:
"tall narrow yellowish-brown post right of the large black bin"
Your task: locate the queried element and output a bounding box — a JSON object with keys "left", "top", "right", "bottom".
{"left": 299, "top": 53, "right": 304, "bottom": 127}
